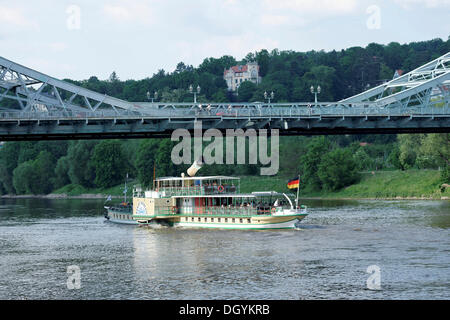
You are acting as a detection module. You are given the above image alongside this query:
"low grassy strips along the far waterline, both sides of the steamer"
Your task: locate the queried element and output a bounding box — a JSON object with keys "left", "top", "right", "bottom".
{"left": 0, "top": 170, "right": 450, "bottom": 200}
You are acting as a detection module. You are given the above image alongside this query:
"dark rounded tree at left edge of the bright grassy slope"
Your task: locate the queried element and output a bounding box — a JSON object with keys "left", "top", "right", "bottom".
{"left": 317, "top": 149, "right": 359, "bottom": 191}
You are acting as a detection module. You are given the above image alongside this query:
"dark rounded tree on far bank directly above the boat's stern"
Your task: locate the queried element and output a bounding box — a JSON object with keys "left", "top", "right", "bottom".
{"left": 91, "top": 140, "right": 127, "bottom": 188}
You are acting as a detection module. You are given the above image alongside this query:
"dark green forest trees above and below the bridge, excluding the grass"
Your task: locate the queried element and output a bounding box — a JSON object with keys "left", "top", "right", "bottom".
{"left": 0, "top": 39, "right": 450, "bottom": 194}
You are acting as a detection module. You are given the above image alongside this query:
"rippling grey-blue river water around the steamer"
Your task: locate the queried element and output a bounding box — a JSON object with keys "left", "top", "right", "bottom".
{"left": 0, "top": 199, "right": 450, "bottom": 299}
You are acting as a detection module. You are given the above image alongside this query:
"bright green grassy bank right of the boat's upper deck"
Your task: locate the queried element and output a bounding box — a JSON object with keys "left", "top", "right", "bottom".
{"left": 241, "top": 170, "right": 450, "bottom": 199}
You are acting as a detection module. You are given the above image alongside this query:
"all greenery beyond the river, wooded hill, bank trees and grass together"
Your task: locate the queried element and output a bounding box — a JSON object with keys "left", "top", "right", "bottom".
{"left": 0, "top": 38, "right": 450, "bottom": 201}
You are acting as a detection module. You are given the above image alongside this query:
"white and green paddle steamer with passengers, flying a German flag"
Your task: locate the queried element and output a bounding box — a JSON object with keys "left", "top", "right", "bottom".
{"left": 105, "top": 162, "right": 308, "bottom": 229}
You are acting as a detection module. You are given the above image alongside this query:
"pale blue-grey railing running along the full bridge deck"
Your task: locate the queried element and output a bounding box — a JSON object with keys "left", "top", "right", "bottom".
{"left": 0, "top": 103, "right": 450, "bottom": 121}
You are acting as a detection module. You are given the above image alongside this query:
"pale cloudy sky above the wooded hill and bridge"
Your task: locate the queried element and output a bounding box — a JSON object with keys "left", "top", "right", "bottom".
{"left": 0, "top": 0, "right": 450, "bottom": 80}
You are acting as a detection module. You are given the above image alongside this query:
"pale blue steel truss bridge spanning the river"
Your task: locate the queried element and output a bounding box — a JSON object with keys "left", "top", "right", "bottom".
{"left": 0, "top": 52, "right": 450, "bottom": 141}
